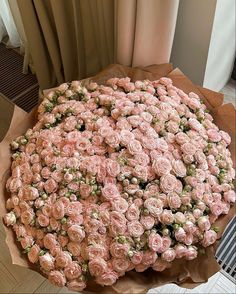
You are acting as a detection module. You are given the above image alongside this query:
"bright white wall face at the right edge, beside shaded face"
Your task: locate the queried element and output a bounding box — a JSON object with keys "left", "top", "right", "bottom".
{"left": 203, "top": 0, "right": 236, "bottom": 91}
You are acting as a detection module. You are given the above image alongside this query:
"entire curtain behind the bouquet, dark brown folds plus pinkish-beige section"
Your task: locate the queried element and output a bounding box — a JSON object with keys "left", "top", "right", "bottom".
{"left": 17, "top": 0, "right": 178, "bottom": 89}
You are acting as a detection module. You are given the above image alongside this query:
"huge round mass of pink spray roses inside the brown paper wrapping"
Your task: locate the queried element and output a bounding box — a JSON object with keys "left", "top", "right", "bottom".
{"left": 4, "top": 78, "right": 235, "bottom": 291}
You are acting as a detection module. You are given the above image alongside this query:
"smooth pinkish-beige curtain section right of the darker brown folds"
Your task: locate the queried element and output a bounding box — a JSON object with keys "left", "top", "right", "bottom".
{"left": 116, "top": 0, "right": 179, "bottom": 66}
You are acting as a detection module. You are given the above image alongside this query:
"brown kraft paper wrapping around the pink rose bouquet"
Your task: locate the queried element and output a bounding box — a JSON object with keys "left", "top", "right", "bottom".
{"left": 0, "top": 64, "right": 236, "bottom": 294}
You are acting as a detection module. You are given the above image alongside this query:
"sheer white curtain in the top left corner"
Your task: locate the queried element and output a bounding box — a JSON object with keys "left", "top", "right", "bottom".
{"left": 0, "top": 0, "right": 21, "bottom": 47}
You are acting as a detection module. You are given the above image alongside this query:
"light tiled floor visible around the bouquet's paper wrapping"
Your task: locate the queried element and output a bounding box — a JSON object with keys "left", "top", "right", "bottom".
{"left": 0, "top": 81, "right": 236, "bottom": 294}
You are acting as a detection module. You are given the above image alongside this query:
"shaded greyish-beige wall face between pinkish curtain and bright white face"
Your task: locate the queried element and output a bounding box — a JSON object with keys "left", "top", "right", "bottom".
{"left": 170, "top": 0, "right": 216, "bottom": 85}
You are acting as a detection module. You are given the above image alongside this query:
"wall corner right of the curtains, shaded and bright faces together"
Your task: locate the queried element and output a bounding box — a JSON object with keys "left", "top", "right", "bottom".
{"left": 170, "top": 0, "right": 236, "bottom": 91}
